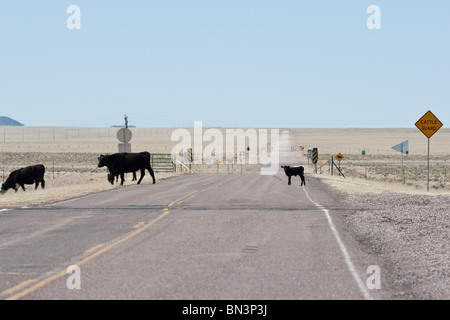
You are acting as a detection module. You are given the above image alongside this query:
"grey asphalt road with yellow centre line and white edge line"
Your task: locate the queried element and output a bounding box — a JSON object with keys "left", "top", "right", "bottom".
{"left": 0, "top": 171, "right": 380, "bottom": 300}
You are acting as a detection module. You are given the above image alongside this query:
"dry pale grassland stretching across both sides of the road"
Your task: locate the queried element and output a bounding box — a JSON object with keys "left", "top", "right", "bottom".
{"left": 0, "top": 127, "right": 450, "bottom": 207}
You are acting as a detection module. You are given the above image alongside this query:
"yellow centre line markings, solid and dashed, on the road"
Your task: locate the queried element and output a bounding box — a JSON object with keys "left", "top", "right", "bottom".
{"left": 0, "top": 188, "right": 199, "bottom": 300}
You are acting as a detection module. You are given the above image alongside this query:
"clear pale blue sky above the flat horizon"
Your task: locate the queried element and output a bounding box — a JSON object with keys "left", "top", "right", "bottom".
{"left": 0, "top": 0, "right": 450, "bottom": 128}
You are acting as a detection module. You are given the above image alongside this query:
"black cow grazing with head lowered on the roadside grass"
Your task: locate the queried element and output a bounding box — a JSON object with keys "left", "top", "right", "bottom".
{"left": 0, "top": 164, "right": 45, "bottom": 194}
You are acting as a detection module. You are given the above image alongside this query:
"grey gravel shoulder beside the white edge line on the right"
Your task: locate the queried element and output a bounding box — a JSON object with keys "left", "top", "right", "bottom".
{"left": 321, "top": 177, "right": 450, "bottom": 300}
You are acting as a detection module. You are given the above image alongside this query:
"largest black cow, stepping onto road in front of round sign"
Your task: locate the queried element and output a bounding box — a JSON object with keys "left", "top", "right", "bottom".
{"left": 97, "top": 151, "right": 155, "bottom": 185}
